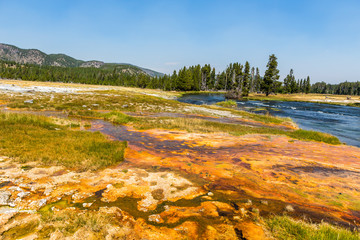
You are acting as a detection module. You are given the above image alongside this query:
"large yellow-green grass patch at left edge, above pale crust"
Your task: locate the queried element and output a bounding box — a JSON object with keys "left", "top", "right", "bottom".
{"left": 0, "top": 113, "right": 126, "bottom": 171}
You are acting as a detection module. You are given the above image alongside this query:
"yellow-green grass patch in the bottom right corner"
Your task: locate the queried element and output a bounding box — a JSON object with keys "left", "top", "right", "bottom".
{"left": 265, "top": 216, "right": 360, "bottom": 240}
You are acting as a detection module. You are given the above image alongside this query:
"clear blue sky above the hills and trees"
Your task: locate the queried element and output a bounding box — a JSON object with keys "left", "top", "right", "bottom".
{"left": 0, "top": 0, "right": 360, "bottom": 83}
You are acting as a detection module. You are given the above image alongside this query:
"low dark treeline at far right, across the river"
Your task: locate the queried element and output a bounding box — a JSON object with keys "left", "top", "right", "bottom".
{"left": 311, "top": 81, "right": 360, "bottom": 96}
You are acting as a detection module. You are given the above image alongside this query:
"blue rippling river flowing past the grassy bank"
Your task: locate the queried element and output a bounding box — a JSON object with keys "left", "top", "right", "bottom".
{"left": 178, "top": 94, "right": 360, "bottom": 147}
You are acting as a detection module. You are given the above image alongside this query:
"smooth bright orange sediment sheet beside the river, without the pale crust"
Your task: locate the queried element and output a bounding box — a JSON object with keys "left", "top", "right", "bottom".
{"left": 126, "top": 127, "right": 360, "bottom": 223}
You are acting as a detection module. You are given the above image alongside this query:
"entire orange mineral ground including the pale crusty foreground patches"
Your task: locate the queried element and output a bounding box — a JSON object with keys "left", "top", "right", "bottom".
{"left": 0, "top": 120, "right": 360, "bottom": 239}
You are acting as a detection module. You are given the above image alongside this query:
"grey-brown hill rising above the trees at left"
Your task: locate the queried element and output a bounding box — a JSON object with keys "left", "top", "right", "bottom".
{"left": 0, "top": 43, "right": 163, "bottom": 77}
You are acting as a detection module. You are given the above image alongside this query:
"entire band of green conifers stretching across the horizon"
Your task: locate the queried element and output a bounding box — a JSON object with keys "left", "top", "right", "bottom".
{"left": 0, "top": 59, "right": 360, "bottom": 95}
